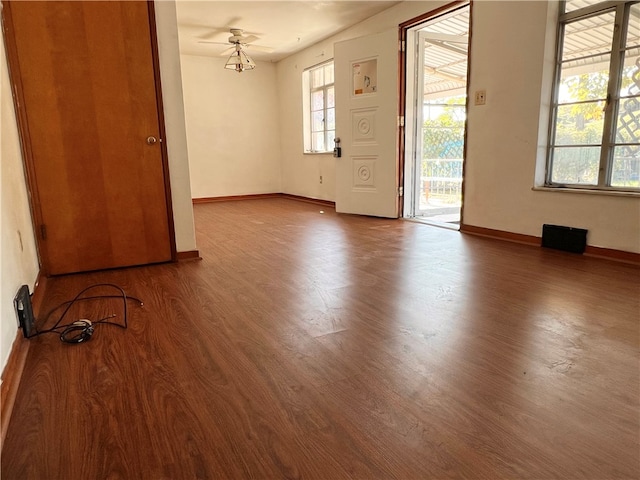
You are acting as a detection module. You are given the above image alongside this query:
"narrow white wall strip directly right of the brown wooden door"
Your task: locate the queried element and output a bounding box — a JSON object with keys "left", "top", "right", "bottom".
{"left": 155, "top": 0, "right": 196, "bottom": 252}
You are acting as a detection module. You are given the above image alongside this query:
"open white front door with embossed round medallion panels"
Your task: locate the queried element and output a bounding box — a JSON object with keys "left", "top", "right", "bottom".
{"left": 334, "top": 29, "right": 399, "bottom": 218}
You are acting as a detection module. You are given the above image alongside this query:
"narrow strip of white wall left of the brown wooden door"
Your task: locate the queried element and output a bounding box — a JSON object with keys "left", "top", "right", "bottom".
{"left": 0, "top": 30, "right": 39, "bottom": 371}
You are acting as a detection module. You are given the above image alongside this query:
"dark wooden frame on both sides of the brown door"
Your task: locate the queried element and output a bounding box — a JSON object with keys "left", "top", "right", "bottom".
{"left": 1, "top": 0, "right": 177, "bottom": 276}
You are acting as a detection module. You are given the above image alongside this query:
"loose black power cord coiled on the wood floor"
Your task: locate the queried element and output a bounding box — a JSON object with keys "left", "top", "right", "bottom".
{"left": 29, "top": 283, "right": 144, "bottom": 343}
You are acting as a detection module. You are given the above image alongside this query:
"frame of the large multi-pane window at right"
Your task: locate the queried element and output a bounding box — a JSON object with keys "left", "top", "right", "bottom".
{"left": 545, "top": 1, "right": 640, "bottom": 193}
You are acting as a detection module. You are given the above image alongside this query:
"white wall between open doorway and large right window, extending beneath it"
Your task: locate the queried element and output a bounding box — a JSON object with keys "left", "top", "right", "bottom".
{"left": 463, "top": 1, "right": 640, "bottom": 252}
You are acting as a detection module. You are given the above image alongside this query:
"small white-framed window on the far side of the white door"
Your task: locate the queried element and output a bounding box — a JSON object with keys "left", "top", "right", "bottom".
{"left": 302, "top": 59, "right": 335, "bottom": 154}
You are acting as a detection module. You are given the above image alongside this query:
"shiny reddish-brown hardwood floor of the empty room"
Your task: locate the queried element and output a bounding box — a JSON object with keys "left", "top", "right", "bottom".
{"left": 2, "top": 199, "right": 640, "bottom": 480}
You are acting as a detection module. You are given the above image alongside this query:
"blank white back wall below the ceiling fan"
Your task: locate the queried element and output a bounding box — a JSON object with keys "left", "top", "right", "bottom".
{"left": 182, "top": 55, "right": 282, "bottom": 198}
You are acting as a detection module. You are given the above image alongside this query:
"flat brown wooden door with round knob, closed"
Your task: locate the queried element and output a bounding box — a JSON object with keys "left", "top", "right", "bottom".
{"left": 3, "top": 1, "right": 175, "bottom": 274}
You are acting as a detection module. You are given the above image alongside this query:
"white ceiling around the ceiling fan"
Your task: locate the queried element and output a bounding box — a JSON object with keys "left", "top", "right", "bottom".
{"left": 176, "top": 0, "right": 400, "bottom": 62}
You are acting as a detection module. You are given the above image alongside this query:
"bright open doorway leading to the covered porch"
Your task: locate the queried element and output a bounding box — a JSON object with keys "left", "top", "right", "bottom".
{"left": 403, "top": 4, "right": 470, "bottom": 229}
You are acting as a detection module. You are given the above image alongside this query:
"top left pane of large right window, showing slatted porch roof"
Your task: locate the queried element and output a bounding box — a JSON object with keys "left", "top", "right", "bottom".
{"left": 562, "top": 12, "right": 615, "bottom": 61}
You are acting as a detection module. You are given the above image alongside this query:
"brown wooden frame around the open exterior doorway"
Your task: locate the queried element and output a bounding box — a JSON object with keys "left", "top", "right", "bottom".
{"left": 398, "top": 0, "right": 473, "bottom": 223}
